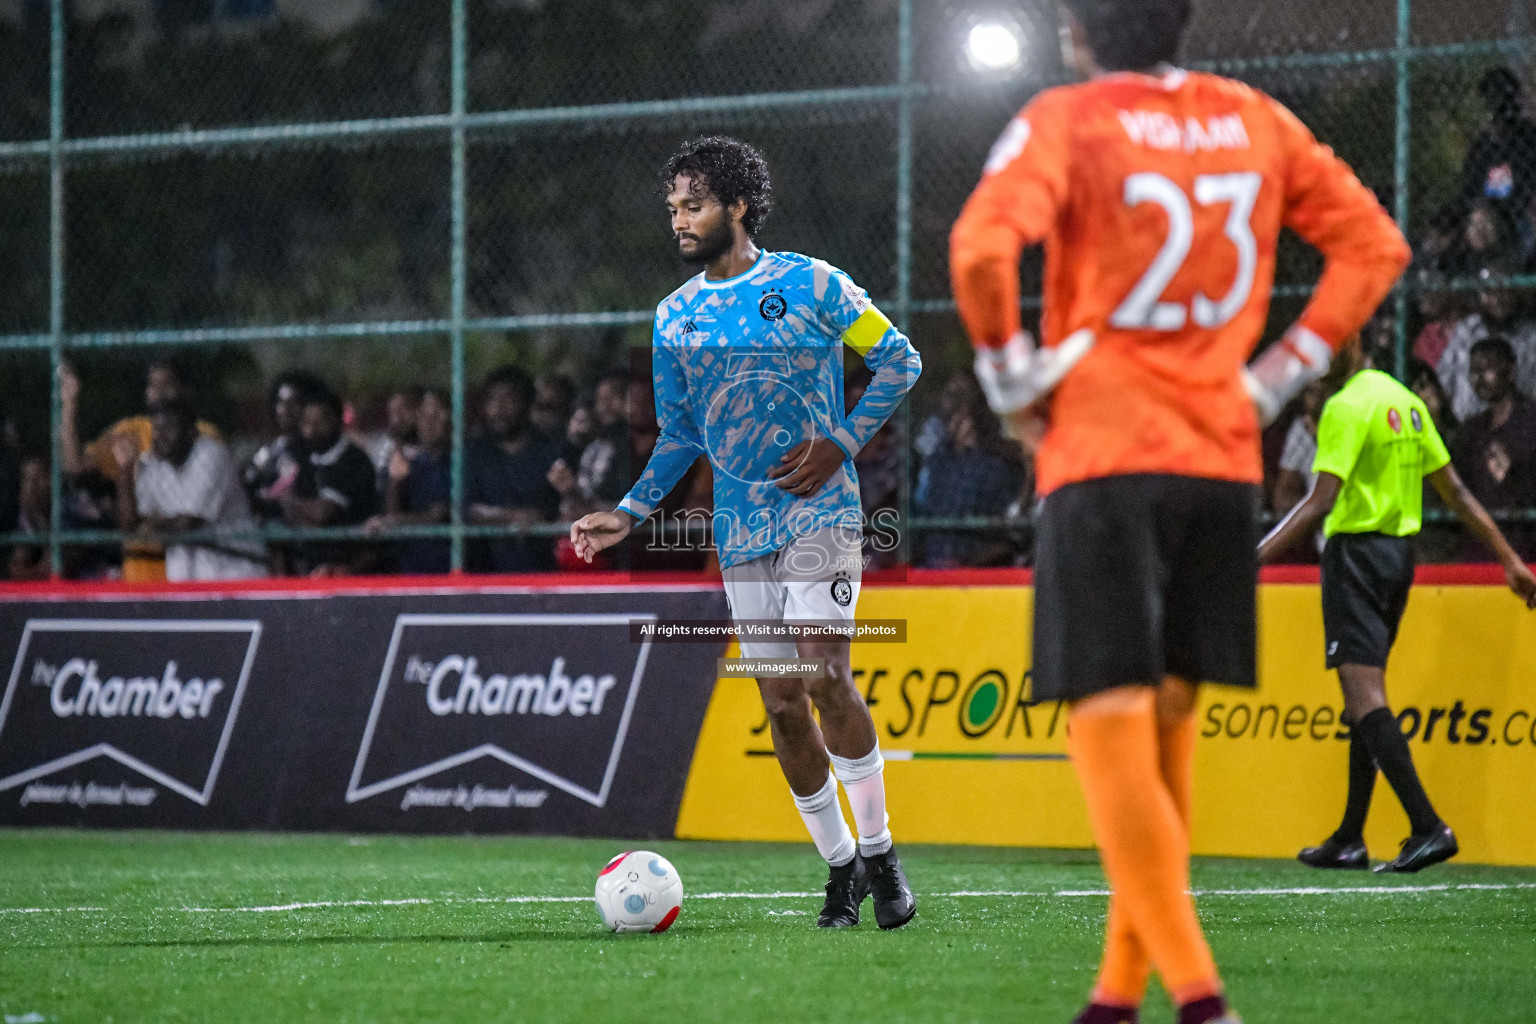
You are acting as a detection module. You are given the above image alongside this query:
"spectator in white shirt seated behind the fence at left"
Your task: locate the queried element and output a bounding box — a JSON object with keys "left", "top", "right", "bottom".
{"left": 112, "top": 399, "right": 267, "bottom": 582}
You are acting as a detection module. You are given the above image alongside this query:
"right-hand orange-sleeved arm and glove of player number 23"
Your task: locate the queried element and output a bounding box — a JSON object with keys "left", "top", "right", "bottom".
{"left": 1247, "top": 100, "right": 1413, "bottom": 424}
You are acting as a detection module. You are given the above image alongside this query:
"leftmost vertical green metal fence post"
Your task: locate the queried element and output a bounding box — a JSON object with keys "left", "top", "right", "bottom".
{"left": 48, "top": 0, "right": 65, "bottom": 579}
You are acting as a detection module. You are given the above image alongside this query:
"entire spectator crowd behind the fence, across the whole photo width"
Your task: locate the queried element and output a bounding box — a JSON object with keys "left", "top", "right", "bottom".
{"left": 0, "top": 68, "right": 1536, "bottom": 582}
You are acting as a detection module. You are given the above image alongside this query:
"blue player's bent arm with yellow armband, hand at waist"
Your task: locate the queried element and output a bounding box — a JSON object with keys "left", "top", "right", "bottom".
{"left": 768, "top": 269, "right": 923, "bottom": 497}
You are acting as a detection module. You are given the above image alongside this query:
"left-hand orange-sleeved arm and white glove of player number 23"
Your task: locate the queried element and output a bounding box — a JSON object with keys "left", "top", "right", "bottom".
{"left": 949, "top": 92, "right": 1094, "bottom": 415}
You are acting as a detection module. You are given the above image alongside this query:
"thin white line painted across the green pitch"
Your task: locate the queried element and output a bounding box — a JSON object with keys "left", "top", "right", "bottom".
{"left": 0, "top": 881, "right": 1536, "bottom": 913}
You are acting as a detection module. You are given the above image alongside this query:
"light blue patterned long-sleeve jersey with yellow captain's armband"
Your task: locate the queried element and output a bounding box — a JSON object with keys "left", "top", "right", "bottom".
{"left": 619, "top": 252, "right": 923, "bottom": 568}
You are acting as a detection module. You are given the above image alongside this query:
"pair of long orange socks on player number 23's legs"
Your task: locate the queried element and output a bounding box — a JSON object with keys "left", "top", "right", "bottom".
{"left": 1068, "top": 688, "right": 1221, "bottom": 1006}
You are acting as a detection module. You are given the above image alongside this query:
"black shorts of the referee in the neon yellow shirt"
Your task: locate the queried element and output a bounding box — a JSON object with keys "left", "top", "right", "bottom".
{"left": 1322, "top": 533, "right": 1413, "bottom": 668}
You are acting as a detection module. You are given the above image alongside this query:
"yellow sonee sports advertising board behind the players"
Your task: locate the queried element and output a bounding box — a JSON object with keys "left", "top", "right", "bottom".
{"left": 677, "top": 585, "right": 1536, "bottom": 864}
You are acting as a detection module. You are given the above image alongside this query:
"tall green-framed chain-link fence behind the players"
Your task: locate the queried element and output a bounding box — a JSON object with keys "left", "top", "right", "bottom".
{"left": 0, "top": 0, "right": 1536, "bottom": 573}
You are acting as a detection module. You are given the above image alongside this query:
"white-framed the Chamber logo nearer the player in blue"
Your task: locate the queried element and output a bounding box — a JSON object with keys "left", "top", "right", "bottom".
{"left": 346, "top": 613, "right": 656, "bottom": 809}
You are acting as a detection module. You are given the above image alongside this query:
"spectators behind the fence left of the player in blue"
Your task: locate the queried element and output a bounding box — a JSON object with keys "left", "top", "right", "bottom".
{"left": 0, "top": 358, "right": 708, "bottom": 582}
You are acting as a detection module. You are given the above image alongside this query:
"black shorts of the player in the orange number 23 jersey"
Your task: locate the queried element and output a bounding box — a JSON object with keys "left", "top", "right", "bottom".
{"left": 1032, "top": 474, "right": 1258, "bottom": 700}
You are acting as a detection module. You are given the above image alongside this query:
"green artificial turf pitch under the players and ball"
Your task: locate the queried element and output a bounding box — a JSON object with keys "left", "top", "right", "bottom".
{"left": 0, "top": 831, "right": 1536, "bottom": 1024}
